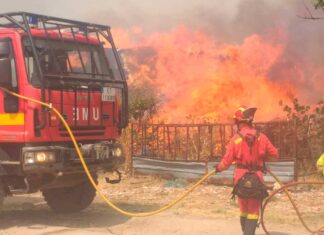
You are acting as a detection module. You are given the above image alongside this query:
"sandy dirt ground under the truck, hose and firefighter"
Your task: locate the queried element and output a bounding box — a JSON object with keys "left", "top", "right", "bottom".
{"left": 0, "top": 173, "right": 324, "bottom": 235}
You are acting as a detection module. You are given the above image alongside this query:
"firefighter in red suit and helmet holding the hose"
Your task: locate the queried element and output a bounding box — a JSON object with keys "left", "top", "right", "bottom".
{"left": 216, "top": 107, "right": 278, "bottom": 235}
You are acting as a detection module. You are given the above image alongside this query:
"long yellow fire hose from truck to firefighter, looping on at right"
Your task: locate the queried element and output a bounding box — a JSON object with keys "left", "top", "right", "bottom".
{"left": 0, "top": 87, "right": 324, "bottom": 234}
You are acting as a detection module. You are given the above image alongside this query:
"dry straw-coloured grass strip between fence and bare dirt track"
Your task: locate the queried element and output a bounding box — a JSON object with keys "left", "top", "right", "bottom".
{"left": 97, "top": 172, "right": 324, "bottom": 228}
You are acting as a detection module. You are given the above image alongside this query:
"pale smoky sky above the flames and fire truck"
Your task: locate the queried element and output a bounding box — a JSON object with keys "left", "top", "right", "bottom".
{"left": 0, "top": 0, "right": 324, "bottom": 44}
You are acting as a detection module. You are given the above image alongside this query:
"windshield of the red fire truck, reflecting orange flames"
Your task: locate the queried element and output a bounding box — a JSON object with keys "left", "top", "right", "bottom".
{"left": 23, "top": 37, "right": 121, "bottom": 84}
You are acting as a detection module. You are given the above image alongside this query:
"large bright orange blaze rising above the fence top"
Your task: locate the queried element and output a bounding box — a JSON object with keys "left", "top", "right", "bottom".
{"left": 114, "top": 26, "right": 306, "bottom": 123}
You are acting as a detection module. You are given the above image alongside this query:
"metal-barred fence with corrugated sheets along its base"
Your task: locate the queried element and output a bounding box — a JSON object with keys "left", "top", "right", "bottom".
{"left": 131, "top": 122, "right": 298, "bottom": 182}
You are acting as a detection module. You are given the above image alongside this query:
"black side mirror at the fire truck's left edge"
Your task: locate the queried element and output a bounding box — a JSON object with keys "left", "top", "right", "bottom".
{"left": 0, "top": 41, "right": 12, "bottom": 88}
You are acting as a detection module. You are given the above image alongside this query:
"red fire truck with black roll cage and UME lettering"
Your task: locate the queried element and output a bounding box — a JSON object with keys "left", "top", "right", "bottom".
{"left": 0, "top": 12, "right": 128, "bottom": 212}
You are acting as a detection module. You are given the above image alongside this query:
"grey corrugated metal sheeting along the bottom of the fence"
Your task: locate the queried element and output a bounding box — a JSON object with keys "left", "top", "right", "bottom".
{"left": 133, "top": 157, "right": 295, "bottom": 183}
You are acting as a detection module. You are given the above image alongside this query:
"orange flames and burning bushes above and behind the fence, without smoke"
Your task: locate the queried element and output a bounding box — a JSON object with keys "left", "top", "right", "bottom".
{"left": 114, "top": 20, "right": 324, "bottom": 172}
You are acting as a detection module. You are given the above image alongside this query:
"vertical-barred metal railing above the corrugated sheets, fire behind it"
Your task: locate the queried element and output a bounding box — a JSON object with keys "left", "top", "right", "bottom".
{"left": 131, "top": 122, "right": 297, "bottom": 161}
